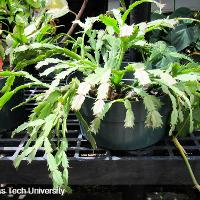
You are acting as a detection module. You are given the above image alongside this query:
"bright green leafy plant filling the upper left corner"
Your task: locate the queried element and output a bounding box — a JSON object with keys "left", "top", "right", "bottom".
{"left": 0, "top": 0, "right": 69, "bottom": 70}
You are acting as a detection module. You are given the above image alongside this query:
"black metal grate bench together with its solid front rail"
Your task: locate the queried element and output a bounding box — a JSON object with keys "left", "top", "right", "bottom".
{"left": 0, "top": 86, "right": 200, "bottom": 185}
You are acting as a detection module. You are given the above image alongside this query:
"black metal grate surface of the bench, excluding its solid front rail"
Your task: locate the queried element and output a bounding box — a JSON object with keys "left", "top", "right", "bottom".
{"left": 0, "top": 126, "right": 200, "bottom": 161}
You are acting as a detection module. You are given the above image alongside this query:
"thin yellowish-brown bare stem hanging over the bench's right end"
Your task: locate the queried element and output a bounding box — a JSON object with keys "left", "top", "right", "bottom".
{"left": 172, "top": 136, "right": 200, "bottom": 192}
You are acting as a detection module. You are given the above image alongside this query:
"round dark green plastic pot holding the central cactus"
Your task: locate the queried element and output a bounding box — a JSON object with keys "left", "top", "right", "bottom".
{"left": 81, "top": 96, "right": 171, "bottom": 150}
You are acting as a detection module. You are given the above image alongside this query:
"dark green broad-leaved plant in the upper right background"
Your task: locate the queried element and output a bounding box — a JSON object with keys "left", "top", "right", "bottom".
{"left": 150, "top": 7, "right": 200, "bottom": 54}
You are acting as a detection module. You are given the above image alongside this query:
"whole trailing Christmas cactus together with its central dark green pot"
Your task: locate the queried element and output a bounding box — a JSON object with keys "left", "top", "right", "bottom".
{"left": 0, "top": 0, "right": 200, "bottom": 192}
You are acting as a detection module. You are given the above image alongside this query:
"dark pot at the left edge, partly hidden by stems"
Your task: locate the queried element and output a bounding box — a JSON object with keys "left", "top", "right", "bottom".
{"left": 0, "top": 78, "right": 26, "bottom": 132}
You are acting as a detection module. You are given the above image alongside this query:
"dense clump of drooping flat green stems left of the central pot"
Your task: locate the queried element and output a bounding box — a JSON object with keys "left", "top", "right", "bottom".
{"left": 10, "top": 80, "right": 78, "bottom": 192}
